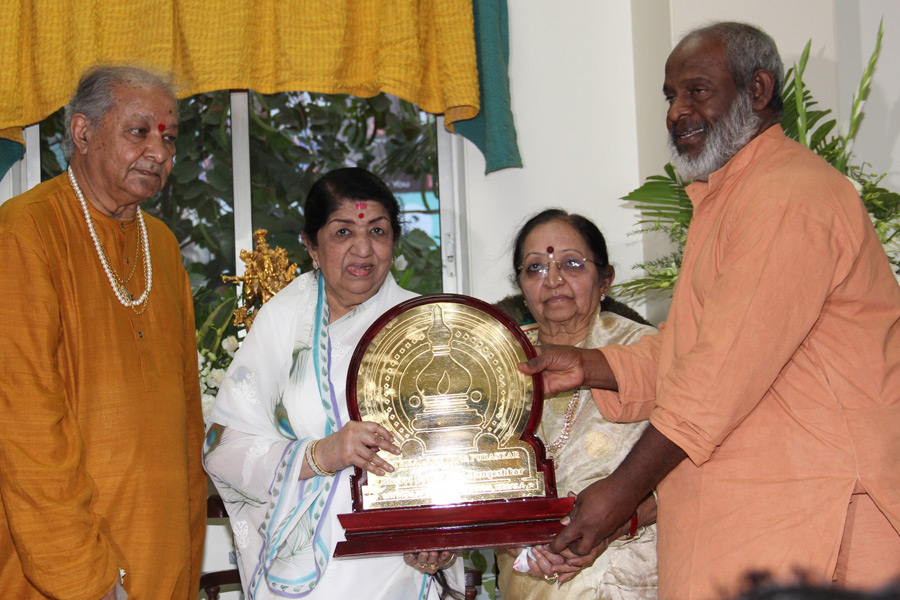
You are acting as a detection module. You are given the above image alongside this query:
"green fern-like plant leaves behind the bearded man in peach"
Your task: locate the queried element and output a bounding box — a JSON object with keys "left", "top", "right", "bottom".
{"left": 616, "top": 25, "right": 900, "bottom": 297}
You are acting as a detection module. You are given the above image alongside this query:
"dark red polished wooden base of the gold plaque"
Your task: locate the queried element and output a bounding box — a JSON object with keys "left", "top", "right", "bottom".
{"left": 334, "top": 498, "right": 575, "bottom": 558}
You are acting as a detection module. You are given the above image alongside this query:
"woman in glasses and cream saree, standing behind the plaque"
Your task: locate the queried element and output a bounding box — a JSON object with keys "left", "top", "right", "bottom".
{"left": 497, "top": 209, "right": 657, "bottom": 600}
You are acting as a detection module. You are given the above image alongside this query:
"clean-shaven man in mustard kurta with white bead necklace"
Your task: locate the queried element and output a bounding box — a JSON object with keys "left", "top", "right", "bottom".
{"left": 0, "top": 67, "right": 206, "bottom": 600}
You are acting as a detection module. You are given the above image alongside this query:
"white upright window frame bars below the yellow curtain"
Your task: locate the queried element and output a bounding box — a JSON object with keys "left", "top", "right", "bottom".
{"left": 8, "top": 98, "right": 471, "bottom": 295}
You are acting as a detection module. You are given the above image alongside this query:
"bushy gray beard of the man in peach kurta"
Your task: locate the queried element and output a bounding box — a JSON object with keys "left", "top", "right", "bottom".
{"left": 668, "top": 93, "right": 762, "bottom": 181}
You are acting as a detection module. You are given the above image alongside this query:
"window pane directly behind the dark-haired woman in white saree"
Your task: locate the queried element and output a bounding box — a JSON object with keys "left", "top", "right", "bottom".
{"left": 250, "top": 92, "right": 442, "bottom": 293}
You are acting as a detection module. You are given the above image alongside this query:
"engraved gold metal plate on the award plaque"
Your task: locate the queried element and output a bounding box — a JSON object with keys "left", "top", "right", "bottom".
{"left": 351, "top": 296, "right": 544, "bottom": 508}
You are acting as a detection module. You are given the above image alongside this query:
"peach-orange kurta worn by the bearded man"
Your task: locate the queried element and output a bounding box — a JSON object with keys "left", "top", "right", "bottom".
{"left": 594, "top": 126, "right": 900, "bottom": 600}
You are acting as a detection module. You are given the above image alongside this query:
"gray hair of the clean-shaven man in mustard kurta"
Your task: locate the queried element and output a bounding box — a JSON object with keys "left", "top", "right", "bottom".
{"left": 64, "top": 65, "right": 175, "bottom": 159}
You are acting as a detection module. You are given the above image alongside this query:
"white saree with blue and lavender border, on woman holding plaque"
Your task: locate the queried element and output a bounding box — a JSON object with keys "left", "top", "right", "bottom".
{"left": 204, "top": 273, "right": 463, "bottom": 600}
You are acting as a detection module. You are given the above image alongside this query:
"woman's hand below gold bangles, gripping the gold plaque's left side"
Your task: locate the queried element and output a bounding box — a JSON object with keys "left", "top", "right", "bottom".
{"left": 316, "top": 421, "right": 400, "bottom": 475}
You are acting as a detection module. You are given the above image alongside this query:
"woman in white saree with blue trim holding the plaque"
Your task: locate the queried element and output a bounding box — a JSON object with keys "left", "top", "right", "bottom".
{"left": 204, "top": 168, "right": 463, "bottom": 600}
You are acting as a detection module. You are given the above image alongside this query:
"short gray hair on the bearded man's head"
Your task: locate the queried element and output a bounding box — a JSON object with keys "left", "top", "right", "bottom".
{"left": 684, "top": 21, "right": 784, "bottom": 120}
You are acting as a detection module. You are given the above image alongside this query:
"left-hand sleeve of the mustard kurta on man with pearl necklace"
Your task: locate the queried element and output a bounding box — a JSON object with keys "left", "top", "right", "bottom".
{"left": 0, "top": 212, "right": 119, "bottom": 600}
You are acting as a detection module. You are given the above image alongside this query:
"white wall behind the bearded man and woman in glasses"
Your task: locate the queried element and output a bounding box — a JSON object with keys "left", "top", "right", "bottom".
{"left": 465, "top": 0, "right": 900, "bottom": 321}
